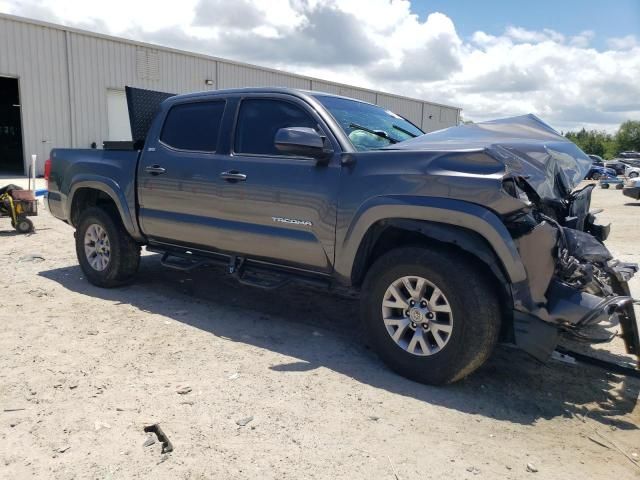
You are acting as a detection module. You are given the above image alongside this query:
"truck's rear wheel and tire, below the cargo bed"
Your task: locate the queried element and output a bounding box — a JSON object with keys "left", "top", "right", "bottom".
{"left": 76, "top": 207, "right": 140, "bottom": 288}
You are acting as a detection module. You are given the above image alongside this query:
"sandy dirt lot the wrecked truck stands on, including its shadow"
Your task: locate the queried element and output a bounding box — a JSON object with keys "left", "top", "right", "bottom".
{"left": 0, "top": 179, "right": 640, "bottom": 480}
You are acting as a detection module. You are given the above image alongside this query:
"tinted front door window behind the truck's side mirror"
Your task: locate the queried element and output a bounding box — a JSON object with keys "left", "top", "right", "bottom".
{"left": 234, "top": 98, "right": 318, "bottom": 156}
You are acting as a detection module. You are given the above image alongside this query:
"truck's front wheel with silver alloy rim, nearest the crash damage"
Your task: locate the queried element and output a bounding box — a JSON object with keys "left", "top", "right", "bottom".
{"left": 361, "top": 247, "right": 501, "bottom": 385}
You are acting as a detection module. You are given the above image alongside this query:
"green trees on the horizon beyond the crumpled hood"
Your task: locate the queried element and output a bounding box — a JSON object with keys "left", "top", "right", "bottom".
{"left": 565, "top": 120, "right": 640, "bottom": 159}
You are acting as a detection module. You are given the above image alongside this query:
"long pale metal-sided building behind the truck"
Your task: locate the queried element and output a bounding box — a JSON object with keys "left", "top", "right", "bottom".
{"left": 0, "top": 14, "right": 460, "bottom": 174}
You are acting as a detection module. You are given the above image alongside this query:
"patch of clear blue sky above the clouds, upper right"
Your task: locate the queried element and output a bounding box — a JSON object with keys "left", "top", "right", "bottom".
{"left": 411, "top": 0, "right": 640, "bottom": 49}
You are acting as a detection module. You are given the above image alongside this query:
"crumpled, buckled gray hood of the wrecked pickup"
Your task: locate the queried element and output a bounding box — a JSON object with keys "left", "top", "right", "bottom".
{"left": 386, "top": 114, "right": 592, "bottom": 199}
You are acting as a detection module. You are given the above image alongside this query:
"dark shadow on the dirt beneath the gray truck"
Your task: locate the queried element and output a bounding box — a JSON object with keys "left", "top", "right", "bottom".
{"left": 40, "top": 255, "right": 640, "bottom": 429}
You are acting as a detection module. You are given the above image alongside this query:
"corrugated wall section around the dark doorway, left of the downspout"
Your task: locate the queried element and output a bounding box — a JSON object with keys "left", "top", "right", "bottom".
{"left": 0, "top": 17, "right": 71, "bottom": 172}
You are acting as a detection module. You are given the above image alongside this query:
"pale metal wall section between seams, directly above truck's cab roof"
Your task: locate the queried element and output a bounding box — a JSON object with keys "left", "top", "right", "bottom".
{"left": 218, "top": 62, "right": 311, "bottom": 90}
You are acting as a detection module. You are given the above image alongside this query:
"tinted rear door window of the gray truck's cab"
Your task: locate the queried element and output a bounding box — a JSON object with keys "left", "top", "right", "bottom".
{"left": 160, "top": 101, "right": 225, "bottom": 152}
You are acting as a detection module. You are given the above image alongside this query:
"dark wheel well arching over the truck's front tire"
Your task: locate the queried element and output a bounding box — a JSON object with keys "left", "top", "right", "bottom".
{"left": 351, "top": 219, "right": 513, "bottom": 339}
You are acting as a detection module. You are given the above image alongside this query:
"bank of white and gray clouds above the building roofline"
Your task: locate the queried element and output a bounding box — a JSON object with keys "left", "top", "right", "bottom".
{"left": 0, "top": 0, "right": 640, "bottom": 130}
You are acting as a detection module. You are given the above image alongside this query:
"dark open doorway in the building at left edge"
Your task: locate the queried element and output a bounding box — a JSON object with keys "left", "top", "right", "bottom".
{"left": 0, "top": 77, "right": 24, "bottom": 174}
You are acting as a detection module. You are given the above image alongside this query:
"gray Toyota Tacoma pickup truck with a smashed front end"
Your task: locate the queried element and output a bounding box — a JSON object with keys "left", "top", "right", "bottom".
{"left": 48, "top": 88, "right": 640, "bottom": 384}
